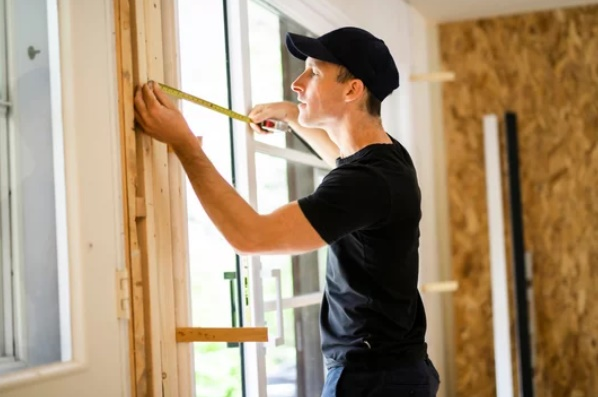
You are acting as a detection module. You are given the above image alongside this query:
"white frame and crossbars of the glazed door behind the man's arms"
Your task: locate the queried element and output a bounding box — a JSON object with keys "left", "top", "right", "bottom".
{"left": 227, "top": 0, "right": 353, "bottom": 397}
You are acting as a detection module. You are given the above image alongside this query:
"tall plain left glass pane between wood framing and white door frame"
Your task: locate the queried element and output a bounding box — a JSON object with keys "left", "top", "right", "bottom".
{"left": 178, "top": 0, "right": 242, "bottom": 396}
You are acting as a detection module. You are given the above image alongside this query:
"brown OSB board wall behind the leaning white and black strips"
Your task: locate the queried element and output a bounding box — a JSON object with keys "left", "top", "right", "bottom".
{"left": 439, "top": 6, "right": 598, "bottom": 397}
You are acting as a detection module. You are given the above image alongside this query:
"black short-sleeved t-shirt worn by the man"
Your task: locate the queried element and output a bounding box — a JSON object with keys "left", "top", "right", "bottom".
{"left": 299, "top": 138, "right": 427, "bottom": 368}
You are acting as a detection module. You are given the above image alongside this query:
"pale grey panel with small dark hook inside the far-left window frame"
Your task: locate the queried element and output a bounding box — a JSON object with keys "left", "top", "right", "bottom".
{"left": 9, "top": 0, "right": 61, "bottom": 365}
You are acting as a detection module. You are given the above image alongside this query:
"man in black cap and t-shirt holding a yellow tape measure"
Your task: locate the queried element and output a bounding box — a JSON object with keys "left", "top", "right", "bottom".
{"left": 135, "top": 28, "right": 439, "bottom": 397}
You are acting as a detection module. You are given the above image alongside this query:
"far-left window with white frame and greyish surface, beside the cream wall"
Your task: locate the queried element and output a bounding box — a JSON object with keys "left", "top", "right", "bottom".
{"left": 0, "top": 0, "right": 71, "bottom": 374}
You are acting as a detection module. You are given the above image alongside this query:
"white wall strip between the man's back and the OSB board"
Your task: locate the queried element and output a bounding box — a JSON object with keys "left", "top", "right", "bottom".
{"left": 322, "top": 0, "right": 454, "bottom": 396}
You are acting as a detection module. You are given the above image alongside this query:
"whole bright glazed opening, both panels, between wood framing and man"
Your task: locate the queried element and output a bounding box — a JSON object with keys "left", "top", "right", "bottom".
{"left": 178, "top": 0, "right": 329, "bottom": 397}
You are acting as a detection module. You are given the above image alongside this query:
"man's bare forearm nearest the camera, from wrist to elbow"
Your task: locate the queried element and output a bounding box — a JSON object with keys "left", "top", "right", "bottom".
{"left": 174, "top": 140, "right": 260, "bottom": 252}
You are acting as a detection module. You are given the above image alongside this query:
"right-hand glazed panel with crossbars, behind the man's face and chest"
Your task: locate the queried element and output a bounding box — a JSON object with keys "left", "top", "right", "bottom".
{"left": 248, "top": 1, "right": 327, "bottom": 397}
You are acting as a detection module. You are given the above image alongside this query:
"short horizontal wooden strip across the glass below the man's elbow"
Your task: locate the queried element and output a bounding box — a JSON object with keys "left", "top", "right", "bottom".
{"left": 176, "top": 327, "right": 268, "bottom": 343}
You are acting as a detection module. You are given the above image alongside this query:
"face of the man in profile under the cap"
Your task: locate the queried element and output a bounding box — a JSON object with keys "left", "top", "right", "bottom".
{"left": 291, "top": 58, "right": 346, "bottom": 127}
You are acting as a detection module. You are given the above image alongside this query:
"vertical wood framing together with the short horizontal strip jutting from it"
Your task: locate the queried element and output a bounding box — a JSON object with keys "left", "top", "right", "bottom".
{"left": 114, "top": 0, "right": 268, "bottom": 397}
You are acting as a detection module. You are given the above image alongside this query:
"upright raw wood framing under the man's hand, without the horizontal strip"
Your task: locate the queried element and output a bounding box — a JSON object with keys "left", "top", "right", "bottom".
{"left": 114, "top": 0, "right": 177, "bottom": 396}
